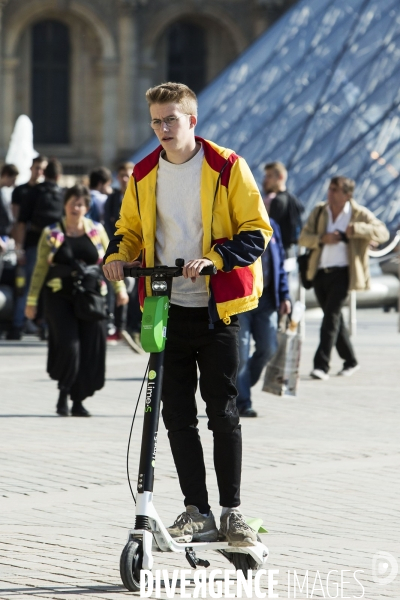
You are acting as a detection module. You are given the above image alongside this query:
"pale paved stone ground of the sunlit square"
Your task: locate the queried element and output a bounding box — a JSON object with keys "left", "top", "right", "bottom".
{"left": 0, "top": 310, "right": 400, "bottom": 600}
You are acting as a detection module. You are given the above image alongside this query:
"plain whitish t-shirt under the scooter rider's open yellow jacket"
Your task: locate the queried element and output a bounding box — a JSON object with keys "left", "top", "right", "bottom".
{"left": 155, "top": 146, "right": 208, "bottom": 307}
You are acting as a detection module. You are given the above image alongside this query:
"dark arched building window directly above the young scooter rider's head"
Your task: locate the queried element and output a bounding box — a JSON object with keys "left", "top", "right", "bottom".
{"left": 167, "top": 21, "right": 207, "bottom": 93}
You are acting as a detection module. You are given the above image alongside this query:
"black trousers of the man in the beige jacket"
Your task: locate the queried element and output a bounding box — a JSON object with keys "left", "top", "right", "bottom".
{"left": 314, "top": 268, "right": 357, "bottom": 373}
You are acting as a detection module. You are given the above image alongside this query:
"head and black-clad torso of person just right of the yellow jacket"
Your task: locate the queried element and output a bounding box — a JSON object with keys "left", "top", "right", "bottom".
{"left": 263, "top": 161, "right": 304, "bottom": 258}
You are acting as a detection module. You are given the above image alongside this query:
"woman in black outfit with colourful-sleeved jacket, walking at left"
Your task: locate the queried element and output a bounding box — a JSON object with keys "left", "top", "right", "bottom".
{"left": 25, "top": 185, "right": 128, "bottom": 417}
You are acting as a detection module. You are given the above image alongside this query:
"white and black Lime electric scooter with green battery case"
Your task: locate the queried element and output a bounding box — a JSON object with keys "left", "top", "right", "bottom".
{"left": 120, "top": 258, "right": 268, "bottom": 592}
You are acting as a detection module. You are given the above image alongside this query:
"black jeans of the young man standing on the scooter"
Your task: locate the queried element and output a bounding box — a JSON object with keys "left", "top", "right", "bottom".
{"left": 162, "top": 305, "right": 242, "bottom": 513}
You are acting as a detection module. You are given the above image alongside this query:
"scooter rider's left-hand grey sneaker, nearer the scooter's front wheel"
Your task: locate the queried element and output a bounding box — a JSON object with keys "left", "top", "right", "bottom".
{"left": 167, "top": 505, "right": 218, "bottom": 542}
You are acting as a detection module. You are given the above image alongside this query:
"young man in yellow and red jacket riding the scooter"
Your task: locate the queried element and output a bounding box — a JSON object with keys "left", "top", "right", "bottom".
{"left": 103, "top": 83, "right": 272, "bottom": 546}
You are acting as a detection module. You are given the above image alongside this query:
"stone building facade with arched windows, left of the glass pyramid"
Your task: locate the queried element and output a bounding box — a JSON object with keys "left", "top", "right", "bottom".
{"left": 0, "top": 0, "right": 294, "bottom": 174}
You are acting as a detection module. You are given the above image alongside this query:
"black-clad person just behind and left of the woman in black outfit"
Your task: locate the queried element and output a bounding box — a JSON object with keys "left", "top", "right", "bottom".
{"left": 7, "top": 158, "right": 64, "bottom": 340}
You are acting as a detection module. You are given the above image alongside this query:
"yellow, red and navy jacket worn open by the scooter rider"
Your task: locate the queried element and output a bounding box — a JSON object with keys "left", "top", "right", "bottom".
{"left": 104, "top": 137, "right": 272, "bottom": 322}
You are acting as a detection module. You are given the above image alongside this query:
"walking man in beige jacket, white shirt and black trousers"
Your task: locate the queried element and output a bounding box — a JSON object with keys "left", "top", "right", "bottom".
{"left": 299, "top": 177, "right": 389, "bottom": 380}
